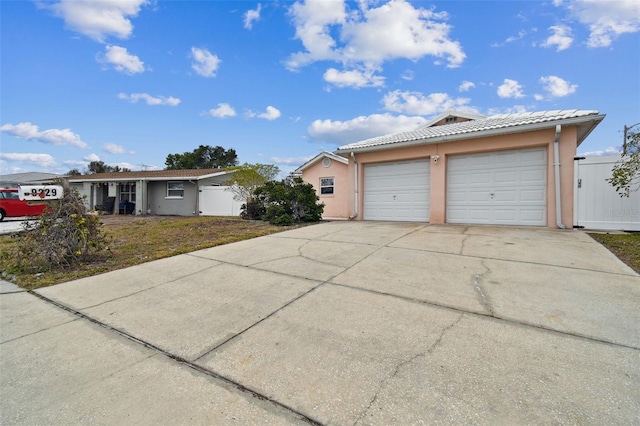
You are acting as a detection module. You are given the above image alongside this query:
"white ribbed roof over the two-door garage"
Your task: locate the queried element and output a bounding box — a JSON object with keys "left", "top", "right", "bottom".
{"left": 336, "top": 109, "right": 605, "bottom": 155}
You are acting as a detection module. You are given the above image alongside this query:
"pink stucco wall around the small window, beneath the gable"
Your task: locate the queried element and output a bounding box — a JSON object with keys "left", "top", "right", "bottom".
{"left": 302, "top": 160, "right": 353, "bottom": 219}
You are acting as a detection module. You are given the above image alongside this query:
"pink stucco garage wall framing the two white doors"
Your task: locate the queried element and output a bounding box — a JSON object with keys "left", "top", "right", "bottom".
{"left": 344, "top": 126, "right": 577, "bottom": 228}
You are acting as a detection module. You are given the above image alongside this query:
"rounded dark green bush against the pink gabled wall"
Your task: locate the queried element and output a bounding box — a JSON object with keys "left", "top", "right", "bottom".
{"left": 241, "top": 178, "right": 324, "bottom": 226}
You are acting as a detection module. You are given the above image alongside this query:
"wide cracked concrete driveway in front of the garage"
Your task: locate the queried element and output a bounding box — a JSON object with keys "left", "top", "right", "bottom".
{"left": 0, "top": 222, "right": 640, "bottom": 425}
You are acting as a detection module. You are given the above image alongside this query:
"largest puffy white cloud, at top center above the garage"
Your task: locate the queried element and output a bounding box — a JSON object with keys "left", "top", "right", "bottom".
{"left": 287, "top": 0, "right": 466, "bottom": 70}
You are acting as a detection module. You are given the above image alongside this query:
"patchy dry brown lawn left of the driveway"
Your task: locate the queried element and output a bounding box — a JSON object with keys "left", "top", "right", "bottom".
{"left": 0, "top": 215, "right": 292, "bottom": 289}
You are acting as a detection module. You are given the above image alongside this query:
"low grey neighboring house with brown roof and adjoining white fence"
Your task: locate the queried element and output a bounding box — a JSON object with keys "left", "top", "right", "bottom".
{"left": 68, "top": 169, "right": 242, "bottom": 216}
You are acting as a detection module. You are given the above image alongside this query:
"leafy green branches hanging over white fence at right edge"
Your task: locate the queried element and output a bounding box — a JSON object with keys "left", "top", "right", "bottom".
{"left": 607, "top": 127, "right": 640, "bottom": 197}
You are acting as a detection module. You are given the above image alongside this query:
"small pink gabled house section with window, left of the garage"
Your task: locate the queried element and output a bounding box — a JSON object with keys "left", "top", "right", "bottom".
{"left": 293, "top": 152, "right": 351, "bottom": 219}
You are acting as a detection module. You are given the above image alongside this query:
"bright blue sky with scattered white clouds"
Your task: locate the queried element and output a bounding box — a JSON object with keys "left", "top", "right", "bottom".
{"left": 0, "top": 0, "right": 640, "bottom": 174}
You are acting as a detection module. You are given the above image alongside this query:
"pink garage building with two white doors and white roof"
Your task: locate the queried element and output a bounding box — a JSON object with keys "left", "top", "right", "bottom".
{"left": 302, "top": 110, "right": 605, "bottom": 228}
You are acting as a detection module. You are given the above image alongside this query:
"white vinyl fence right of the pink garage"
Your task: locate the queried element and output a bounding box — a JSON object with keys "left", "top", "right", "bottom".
{"left": 574, "top": 156, "right": 640, "bottom": 231}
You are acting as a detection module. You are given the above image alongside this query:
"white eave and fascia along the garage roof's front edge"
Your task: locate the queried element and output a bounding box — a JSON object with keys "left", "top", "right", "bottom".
{"left": 336, "top": 114, "right": 605, "bottom": 155}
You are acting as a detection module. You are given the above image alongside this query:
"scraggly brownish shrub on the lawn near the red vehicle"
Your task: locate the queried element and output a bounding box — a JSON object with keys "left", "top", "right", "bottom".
{"left": 13, "top": 190, "right": 107, "bottom": 272}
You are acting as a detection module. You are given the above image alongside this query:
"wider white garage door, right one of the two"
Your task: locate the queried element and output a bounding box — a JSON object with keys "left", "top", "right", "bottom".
{"left": 447, "top": 148, "right": 547, "bottom": 226}
